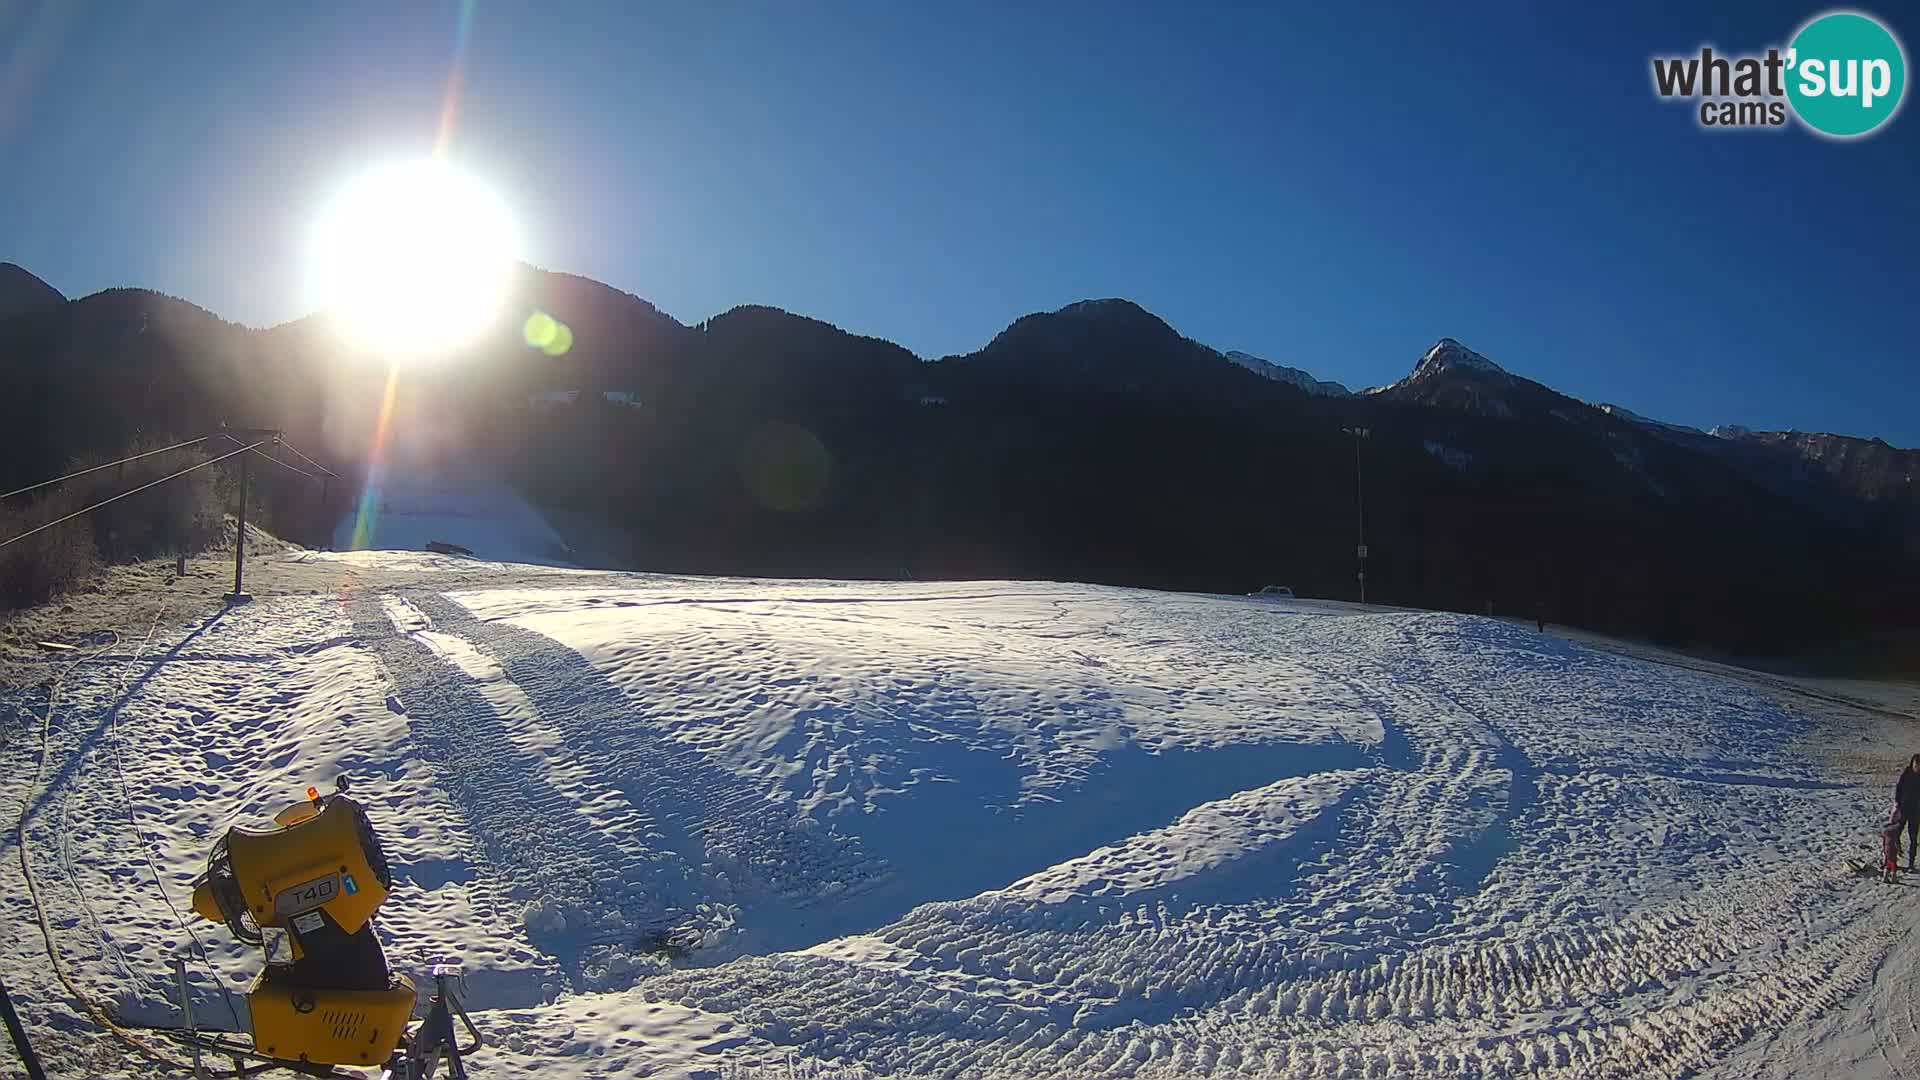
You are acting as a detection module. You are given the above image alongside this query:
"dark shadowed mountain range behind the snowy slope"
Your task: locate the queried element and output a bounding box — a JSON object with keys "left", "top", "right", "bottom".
{"left": 0, "top": 271, "right": 1920, "bottom": 669}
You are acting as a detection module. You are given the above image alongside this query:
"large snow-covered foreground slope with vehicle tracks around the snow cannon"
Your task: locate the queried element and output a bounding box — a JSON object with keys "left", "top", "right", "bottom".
{"left": 0, "top": 553, "right": 1920, "bottom": 1080}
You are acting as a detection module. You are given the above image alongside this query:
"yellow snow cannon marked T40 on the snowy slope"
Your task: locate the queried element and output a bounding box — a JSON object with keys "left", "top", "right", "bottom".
{"left": 194, "top": 778, "right": 420, "bottom": 1067}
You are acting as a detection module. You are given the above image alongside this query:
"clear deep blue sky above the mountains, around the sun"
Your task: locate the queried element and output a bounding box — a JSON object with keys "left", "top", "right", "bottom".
{"left": 0, "top": 0, "right": 1920, "bottom": 446}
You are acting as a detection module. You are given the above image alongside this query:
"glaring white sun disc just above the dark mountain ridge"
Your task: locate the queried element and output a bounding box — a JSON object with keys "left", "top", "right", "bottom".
{"left": 311, "top": 160, "right": 518, "bottom": 357}
